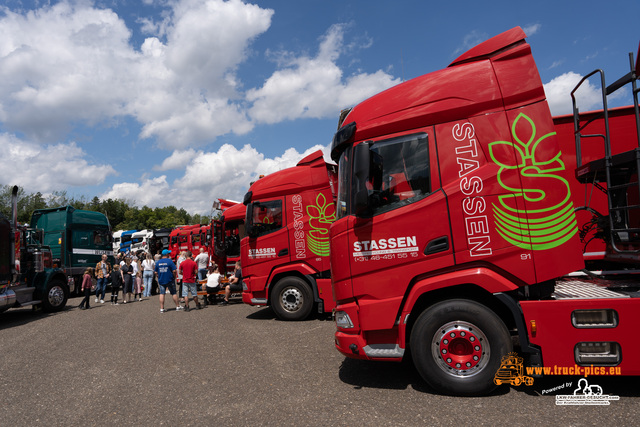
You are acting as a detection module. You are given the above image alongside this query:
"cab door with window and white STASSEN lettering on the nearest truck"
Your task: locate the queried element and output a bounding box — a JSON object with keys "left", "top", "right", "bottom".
{"left": 349, "top": 127, "right": 454, "bottom": 330}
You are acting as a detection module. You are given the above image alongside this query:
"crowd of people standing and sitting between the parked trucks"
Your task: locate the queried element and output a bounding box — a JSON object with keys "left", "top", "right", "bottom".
{"left": 78, "top": 248, "right": 242, "bottom": 313}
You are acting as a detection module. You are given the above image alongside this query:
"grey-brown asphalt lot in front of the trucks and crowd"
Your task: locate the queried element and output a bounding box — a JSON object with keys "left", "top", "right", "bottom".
{"left": 0, "top": 296, "right": 640, "bottom": 426}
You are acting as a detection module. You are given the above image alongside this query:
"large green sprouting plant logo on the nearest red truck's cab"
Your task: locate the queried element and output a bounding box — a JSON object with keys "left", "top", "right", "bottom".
{"left": 489, "top": 113, "right": 578, "bottom": 250}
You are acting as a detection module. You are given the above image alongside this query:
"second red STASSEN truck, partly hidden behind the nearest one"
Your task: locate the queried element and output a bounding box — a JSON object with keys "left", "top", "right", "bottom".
{"left": 240, "top": 151, "right": 335, "bottom": 320}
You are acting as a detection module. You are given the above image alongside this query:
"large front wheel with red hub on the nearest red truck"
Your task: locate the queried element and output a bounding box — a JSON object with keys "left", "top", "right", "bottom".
{"left": 410, "top": 299, "right": 512, "bottom": 396}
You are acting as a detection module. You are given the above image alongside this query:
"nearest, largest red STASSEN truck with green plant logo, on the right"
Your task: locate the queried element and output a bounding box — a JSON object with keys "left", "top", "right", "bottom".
{"left": 330, "top": 28, "right": 640, "bottom": 395}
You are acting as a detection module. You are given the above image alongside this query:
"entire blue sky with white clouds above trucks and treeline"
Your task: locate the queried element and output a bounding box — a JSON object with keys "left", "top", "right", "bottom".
{"left": 0, "top": 0, "right": 640, "bottom": 213}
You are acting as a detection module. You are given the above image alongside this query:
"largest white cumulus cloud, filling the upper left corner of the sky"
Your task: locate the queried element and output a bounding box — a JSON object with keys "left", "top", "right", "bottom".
{"left": 0, "top": 0, "right": 273, "bottom": 149}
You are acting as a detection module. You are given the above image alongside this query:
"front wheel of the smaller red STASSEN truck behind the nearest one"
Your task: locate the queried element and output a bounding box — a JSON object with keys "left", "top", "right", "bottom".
{"left": 271, "top": 277, "right": 313, "bottom": 320}
